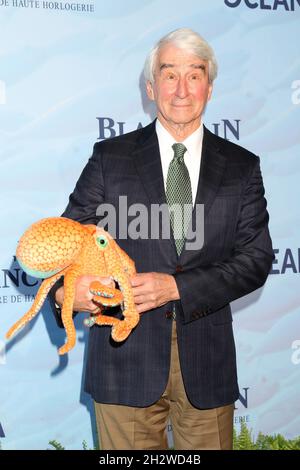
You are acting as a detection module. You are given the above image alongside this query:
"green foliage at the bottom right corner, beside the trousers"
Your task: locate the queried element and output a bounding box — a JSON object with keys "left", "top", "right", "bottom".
{"left": 233, "top": 423, "right": 300, "bottom": 450}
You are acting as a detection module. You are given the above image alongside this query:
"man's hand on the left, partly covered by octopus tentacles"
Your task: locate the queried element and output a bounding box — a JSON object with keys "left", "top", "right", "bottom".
{"left": 55, "top": 276, "right": 115, "bottom": 314}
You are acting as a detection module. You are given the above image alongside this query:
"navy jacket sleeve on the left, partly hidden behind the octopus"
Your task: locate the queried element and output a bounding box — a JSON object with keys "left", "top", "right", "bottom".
{"left": 48, "top": 144, "right": 104, "bottom": 328}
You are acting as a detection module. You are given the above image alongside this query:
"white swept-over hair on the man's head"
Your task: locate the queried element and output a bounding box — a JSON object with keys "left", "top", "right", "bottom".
{"left": 144, "top": 28, "right": 218, "bottom": 83}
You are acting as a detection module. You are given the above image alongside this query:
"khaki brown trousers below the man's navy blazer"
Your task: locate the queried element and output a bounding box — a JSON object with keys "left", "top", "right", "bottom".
{"left": 95, "top": 321, "right": 234, "bottom": 450}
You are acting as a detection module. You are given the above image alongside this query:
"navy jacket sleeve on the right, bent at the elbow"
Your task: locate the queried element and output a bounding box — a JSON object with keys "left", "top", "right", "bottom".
{"left": 174, "top": 158, "right": 274, "bottom": 323}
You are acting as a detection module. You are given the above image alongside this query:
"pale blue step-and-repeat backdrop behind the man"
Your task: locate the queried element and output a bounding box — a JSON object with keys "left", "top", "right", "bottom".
{"left": 0, "top": 0, "right": 300, "bottom": 449}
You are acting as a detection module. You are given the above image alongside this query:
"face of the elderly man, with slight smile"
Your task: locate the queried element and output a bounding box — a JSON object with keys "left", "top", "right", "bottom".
{"left": 147, "top": 44, "right": 212, "bottom": 131}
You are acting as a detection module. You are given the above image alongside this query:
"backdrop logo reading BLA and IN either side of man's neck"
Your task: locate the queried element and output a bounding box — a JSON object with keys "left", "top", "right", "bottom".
{"left": 96, "top": 117, "right": 241, "bottom": 140}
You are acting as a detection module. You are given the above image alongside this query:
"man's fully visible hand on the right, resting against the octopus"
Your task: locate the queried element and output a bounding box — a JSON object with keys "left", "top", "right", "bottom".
{"left": 131, "top": 273, "right": 180, "bottom": 313}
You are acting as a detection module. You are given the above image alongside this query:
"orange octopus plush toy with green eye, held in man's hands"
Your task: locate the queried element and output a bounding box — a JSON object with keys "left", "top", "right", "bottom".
{"left": 6, "top": 217, "right": 139, "bottom": 354}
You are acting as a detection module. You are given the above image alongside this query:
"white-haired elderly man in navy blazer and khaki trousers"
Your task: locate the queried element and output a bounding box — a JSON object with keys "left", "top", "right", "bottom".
{"left": 52, "top": 29, "right": 273, "bottom": 450}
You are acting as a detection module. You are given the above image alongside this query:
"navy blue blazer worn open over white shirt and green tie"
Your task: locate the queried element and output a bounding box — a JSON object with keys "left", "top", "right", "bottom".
{"left": 49, "top": 123, "right": 273, "bottom": 408}
